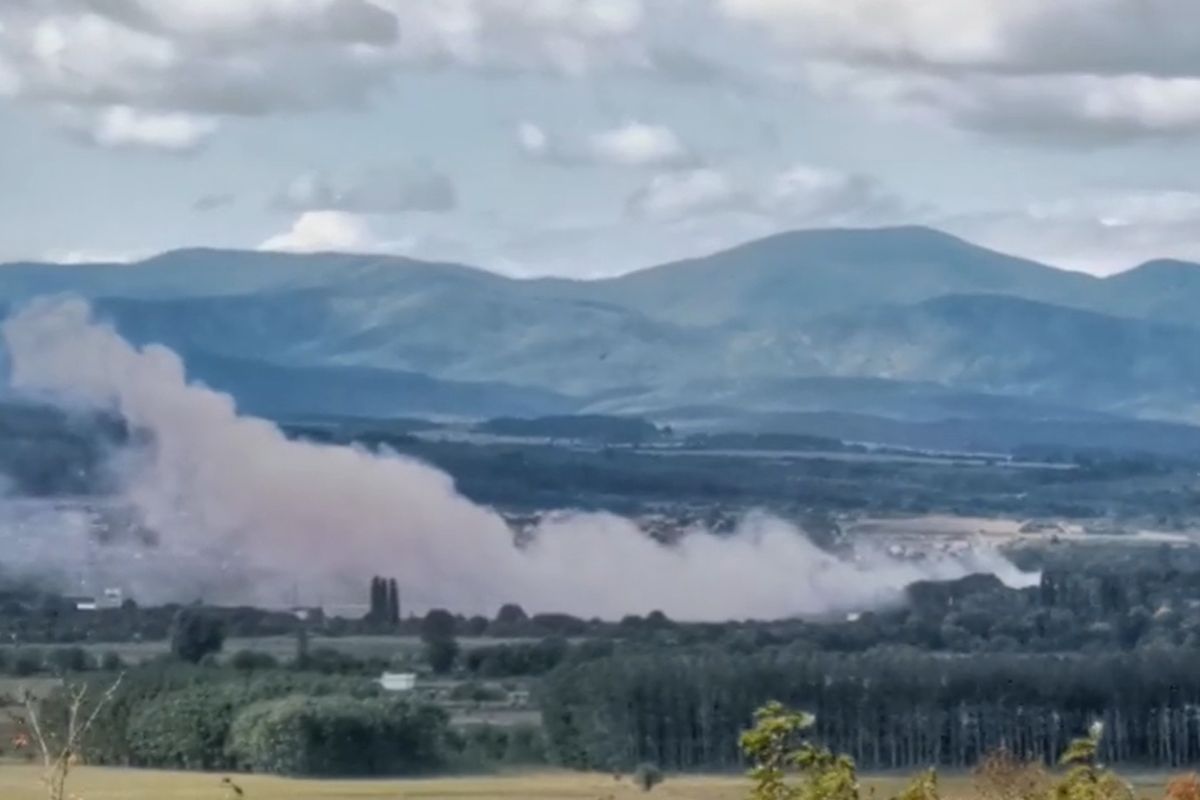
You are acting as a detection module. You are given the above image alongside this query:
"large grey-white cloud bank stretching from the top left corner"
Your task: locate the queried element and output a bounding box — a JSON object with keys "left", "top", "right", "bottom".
{"left": 0, "top": 0, "right": 667, "bottom": 149}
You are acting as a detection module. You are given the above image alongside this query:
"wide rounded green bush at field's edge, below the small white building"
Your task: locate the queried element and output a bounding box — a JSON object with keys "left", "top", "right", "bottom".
{"left": 229, "top": 696, "right": 448, "bottom": 776}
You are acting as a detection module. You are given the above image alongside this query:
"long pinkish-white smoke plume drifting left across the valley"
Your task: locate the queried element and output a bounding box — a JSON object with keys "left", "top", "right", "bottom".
{"left": 2, "top": 299, "right": 1028, "bottom": 619}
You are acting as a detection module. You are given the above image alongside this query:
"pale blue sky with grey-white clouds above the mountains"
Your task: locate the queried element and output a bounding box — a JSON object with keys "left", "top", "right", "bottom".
{"left": 7, "top": 0, "right": 1200, "bottom": 277}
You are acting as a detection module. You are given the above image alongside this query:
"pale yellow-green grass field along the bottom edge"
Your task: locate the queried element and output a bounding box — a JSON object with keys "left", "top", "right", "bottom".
{"left": 0, "top": 764, "right": 1165, "bottom": 800}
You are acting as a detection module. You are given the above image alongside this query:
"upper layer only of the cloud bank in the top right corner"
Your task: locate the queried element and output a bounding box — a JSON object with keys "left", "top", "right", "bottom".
{"left": 716, "top": 0, "right": 1200, "bottom": 77}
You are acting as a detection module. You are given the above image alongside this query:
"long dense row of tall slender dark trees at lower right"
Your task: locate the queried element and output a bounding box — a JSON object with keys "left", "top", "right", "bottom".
{"left": 541, "top": 649, "right": 1200, "bottom": 771}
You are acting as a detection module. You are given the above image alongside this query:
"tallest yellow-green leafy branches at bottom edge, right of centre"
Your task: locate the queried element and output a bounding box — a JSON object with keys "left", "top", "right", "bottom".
{"left": 740, "top": 703, "right": 858, "bottom": 800}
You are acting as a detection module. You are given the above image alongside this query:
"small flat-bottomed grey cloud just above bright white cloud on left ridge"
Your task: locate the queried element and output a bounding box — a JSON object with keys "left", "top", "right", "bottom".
{"left": 275, "top": 166, "right": 458, "bottom": 213}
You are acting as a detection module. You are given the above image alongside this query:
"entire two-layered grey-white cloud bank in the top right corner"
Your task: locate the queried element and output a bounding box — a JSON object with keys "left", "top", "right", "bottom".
{"left": 718, "top": 0, "right": 1200, "bottom": 143}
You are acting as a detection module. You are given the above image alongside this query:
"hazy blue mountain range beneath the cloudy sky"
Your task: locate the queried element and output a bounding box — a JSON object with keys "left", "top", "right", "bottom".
{"left": 7, "top": 228, "right": 1200, "bottom": 448}
